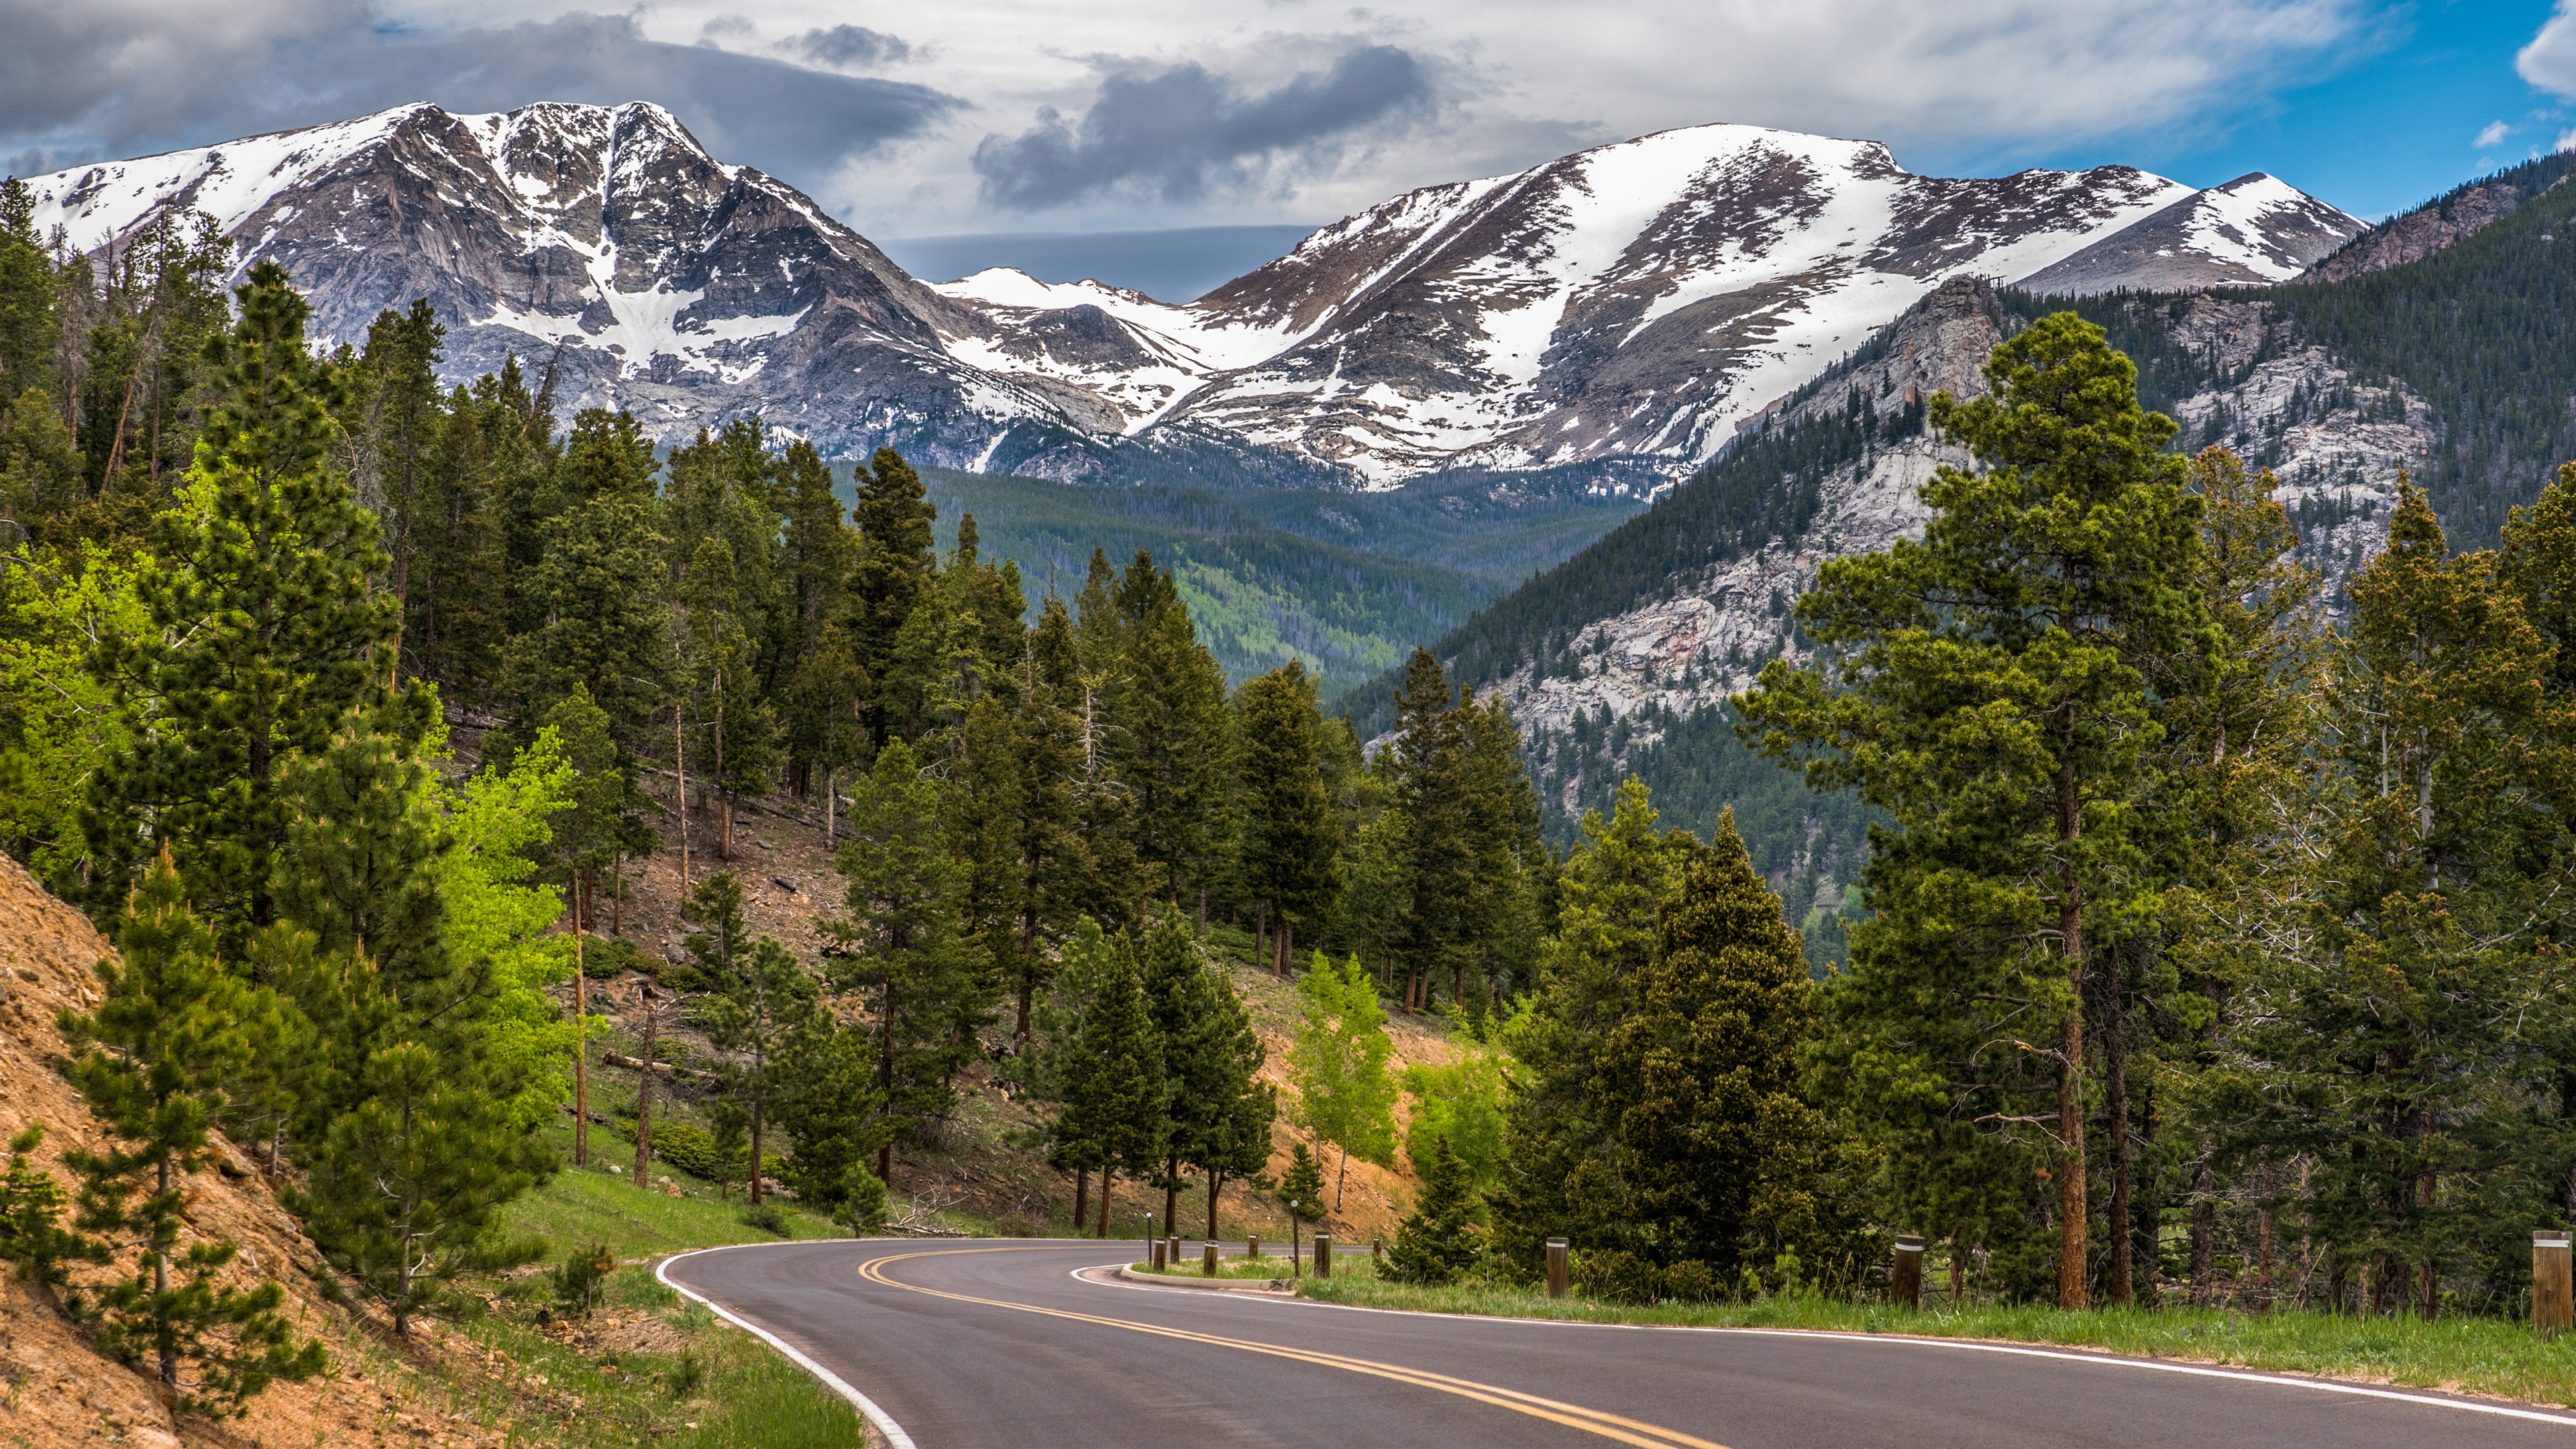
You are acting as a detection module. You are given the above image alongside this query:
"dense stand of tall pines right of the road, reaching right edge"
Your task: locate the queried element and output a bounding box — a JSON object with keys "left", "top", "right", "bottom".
{"left": 1739, "top": 315, "right": 2576, "bottom": 1315}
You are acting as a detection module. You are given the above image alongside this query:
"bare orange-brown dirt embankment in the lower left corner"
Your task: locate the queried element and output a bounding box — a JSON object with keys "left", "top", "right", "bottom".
{"left": 0, "top": 856, "right": 500, "bottom": 1449}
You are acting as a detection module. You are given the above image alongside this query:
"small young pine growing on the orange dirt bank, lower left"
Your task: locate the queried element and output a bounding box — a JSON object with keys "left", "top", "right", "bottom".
{"left": 59, "top": 851, "right": 325, "bottom": 1415}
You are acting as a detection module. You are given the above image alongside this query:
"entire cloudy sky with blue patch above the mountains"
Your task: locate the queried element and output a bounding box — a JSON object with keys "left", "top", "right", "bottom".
{"left": 0, "top": 0, "right": 2576, "bottom": 296}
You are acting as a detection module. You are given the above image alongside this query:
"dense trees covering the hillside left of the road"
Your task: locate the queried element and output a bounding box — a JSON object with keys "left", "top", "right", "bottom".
{"left": 0, "top": 217, "right": 1551, "bottom": 1371}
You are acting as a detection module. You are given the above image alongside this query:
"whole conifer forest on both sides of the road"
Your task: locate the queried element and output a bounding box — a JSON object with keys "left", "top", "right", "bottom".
{"left": 0, "top": 164, "right": 2576, "bottom": 1413}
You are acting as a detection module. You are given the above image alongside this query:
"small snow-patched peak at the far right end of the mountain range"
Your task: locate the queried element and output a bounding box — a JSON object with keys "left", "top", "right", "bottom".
{"left": 2020, "top": 170, "right": 2370, "bottom": 297}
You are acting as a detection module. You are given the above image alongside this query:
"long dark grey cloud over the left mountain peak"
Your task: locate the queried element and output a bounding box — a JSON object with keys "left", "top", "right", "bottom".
{"left": 0, "top": 0, "right": 961, "bottom": 186}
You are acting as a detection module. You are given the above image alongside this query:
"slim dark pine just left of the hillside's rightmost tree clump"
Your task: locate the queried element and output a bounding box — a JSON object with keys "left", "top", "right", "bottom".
{"left": 1236, "top": 660, "right": 1342, "bottom": 975}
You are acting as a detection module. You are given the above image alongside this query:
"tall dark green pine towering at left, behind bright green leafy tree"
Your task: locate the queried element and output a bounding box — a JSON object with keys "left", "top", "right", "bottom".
{"left": 83, "top": 263, "right": 396, "bottom": 954}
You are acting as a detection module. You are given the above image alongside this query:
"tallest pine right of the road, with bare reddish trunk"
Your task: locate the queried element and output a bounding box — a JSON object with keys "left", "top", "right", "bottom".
{"left": 1736, "top": 315, "right": 2208, "bottom": 1307}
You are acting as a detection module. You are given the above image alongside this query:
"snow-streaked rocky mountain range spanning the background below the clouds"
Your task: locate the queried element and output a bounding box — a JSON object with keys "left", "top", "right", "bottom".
{"left": 15, "top": 103, "right": 2349, "bottom": 487}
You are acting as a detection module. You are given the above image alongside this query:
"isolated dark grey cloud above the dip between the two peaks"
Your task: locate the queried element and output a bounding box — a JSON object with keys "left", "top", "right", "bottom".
{"left": 974, "top": 46, "right": 1432, "bottom": 209}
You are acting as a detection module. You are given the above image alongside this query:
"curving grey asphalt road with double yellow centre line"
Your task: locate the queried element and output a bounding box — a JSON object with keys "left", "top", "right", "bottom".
{"left": 665, "top": 1240, "right": 2576, "bottom": 1449}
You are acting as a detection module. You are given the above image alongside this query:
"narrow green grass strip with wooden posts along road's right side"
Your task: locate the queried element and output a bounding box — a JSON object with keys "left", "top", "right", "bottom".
{"left": 1298, "top": 1276, "right": 2576, "bottom": 1408}
